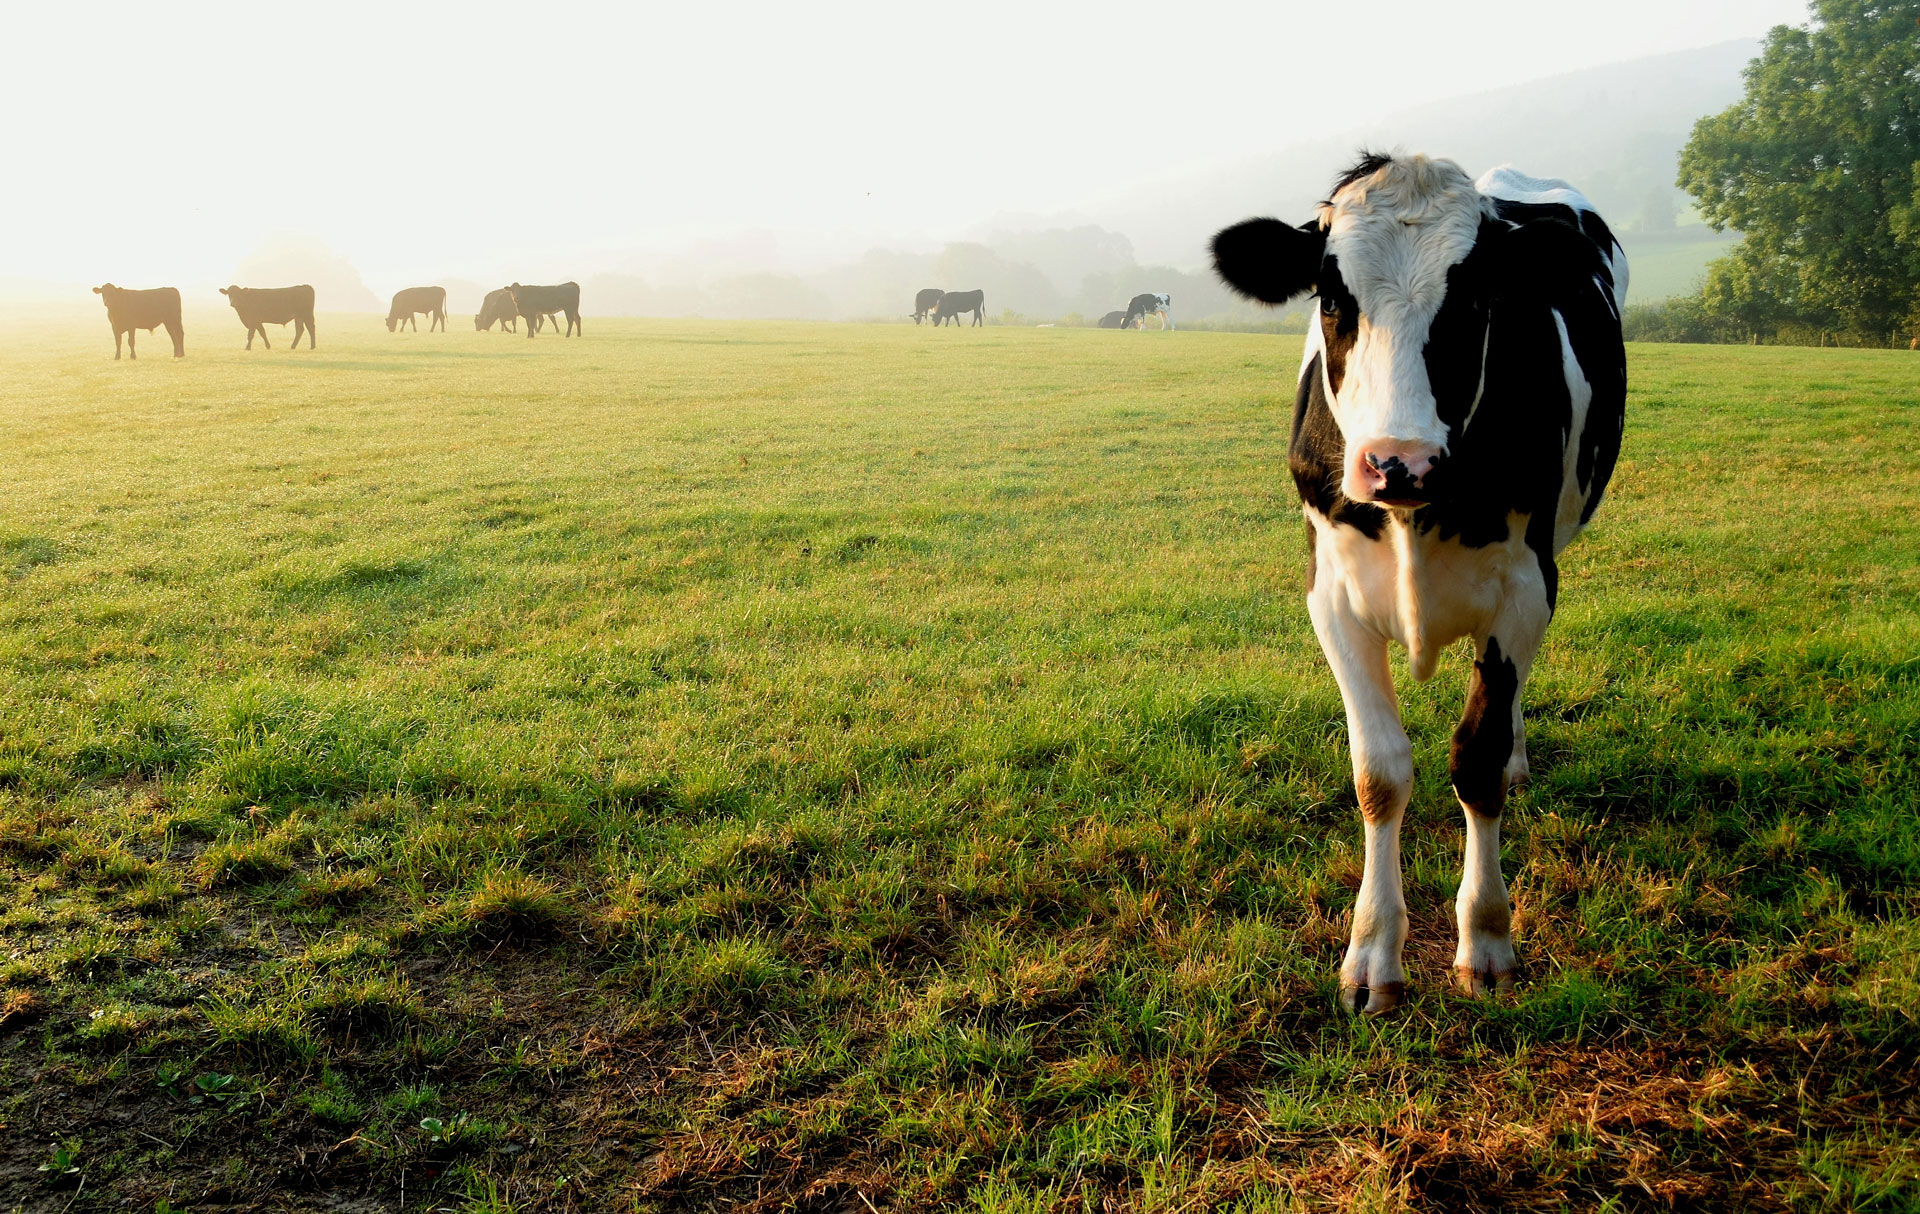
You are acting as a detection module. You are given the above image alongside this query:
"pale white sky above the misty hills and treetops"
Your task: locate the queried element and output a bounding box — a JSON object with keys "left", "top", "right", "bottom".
{"left": 0, "top": 0, "right": 1807, "bottom": 292}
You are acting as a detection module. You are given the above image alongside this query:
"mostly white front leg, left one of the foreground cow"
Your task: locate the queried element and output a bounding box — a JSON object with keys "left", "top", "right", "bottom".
{"left": 1308, "top": 569, "right": 1413, "bottom": 1016}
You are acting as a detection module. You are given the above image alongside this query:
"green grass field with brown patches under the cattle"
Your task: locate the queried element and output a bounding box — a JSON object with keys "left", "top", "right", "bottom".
{"left": 0, "top": 315, "right": 1920, "bottom": 1214}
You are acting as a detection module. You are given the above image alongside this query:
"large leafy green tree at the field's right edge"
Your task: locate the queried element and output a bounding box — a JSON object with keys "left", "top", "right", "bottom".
{"left": 1680, "top": 0, "right": 1920, "bottom": 344}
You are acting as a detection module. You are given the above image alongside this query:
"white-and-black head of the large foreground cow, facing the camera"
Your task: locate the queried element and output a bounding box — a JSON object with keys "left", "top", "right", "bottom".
{"left": 1213, "top": 156, "right": 1498, "bottom": 507}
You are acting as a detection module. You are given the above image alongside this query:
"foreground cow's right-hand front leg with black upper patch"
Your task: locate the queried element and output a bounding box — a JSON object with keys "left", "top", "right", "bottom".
{"left": 1452, "top": 578, "right": 1553, "bottom": 995}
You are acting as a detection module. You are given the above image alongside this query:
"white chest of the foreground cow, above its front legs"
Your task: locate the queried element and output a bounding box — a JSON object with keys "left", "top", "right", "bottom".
{"left": 1306, "top": 509, "right": 1538, "bottom": 680}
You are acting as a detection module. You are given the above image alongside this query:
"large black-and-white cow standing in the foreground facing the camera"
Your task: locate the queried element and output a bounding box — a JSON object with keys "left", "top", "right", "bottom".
{"left": 1213, "top": 156, "right": 1626, "bottom": 1012}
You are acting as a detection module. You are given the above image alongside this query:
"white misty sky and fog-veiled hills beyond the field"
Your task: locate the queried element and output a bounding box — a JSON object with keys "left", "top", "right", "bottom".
{"left": 0, "top": 0, "right": 1805, "bottom": 323}
